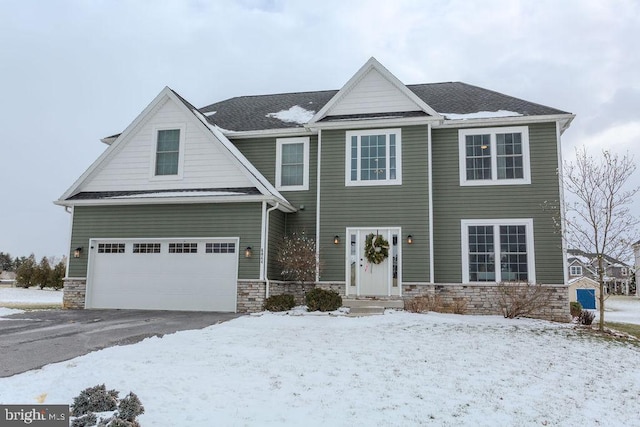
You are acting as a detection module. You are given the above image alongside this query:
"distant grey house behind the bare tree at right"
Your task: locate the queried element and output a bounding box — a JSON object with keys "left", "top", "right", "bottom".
{"left": 567, "top": 249, "right": 633, "bottom": 295}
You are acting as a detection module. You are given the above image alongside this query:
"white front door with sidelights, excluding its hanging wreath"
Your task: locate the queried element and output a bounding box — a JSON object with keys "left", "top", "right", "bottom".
{"left": 347, "top": 228, "right": 399, "bottom": 296}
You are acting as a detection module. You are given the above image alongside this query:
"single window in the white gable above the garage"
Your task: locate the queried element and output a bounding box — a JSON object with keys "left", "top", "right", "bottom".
{"left": 152, "top": 126, "right": 184, "bottom": 179}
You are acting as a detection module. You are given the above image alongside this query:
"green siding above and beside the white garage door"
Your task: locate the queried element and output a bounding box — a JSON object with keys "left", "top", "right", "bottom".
{"left": 68, "top": 203, "right": 262, "bottom": 279}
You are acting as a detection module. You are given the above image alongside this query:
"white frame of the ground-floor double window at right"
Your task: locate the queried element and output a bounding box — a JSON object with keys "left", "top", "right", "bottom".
{"left": 460, "top": 218, "right": 536, "bottom": 284}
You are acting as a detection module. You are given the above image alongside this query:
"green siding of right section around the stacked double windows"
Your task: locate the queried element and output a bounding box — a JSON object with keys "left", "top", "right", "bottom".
{"left": 432, "top": 123, "right": 564, "bottom": 284}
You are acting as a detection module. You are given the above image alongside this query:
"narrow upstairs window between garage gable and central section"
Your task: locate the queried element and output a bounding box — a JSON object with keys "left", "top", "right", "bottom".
{"left": 276, "top": 137, "right": 309, "bottom": 191}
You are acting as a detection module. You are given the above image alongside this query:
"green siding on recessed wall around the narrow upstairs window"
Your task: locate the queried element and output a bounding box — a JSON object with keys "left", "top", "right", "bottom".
{"left": 233, "top": 135, "right": 318, "bottom": 236}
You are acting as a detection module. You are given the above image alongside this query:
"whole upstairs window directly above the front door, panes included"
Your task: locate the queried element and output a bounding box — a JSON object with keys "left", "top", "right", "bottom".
{"left": 345, "top": 129, "right": 402, "bottom": 185}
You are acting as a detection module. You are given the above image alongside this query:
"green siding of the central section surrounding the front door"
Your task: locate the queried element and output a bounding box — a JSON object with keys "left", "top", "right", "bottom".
{"left": 319, "top": 126, "right": 429, "bottom": 282}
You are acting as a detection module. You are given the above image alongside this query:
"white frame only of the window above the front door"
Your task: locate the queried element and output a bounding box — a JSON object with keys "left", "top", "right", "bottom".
{"left": 345, "top": 128, "right": 402, "bottom": 187}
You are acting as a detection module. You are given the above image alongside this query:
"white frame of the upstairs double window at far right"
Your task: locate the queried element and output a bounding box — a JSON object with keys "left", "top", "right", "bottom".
{"left": 458, "top": 126, "right": 531, "bottom": 186}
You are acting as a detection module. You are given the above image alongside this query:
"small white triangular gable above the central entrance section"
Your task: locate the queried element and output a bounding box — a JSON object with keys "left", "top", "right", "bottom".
{"left": 309, "top": 57, "right": 441, "bottom": 125}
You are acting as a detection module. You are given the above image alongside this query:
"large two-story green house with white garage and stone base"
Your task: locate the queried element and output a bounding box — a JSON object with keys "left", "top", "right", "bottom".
{"left": 55, "top": 58, "right": 574, "bottom": 319}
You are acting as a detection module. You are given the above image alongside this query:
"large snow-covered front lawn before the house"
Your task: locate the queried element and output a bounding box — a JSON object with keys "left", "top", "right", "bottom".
{"left": 0, "top": 311, "right": 640, "bottom": 426}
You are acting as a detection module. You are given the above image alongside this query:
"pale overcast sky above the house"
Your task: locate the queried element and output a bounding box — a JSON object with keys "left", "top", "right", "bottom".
{"left": 0, "top": 0, "right": 640, "bottom": 258}
